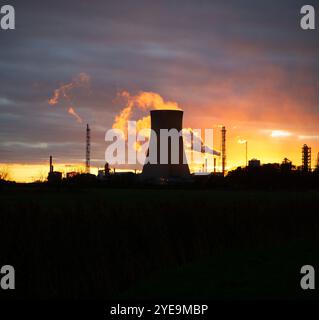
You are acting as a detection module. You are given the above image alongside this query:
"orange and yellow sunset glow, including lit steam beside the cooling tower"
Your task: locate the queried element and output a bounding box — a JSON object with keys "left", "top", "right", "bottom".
{"left": 0, "top": 82, "right": 319, "bottom": 182}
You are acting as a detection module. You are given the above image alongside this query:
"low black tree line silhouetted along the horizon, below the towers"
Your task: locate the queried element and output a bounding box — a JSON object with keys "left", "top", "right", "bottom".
{"left": 0, "top": 159, "right": 319, "bottom": 189}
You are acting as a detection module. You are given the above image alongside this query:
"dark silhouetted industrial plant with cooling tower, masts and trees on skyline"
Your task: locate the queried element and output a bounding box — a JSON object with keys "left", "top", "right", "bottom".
{"left": 40, "top": 110, "right": 319, "bottom": 185}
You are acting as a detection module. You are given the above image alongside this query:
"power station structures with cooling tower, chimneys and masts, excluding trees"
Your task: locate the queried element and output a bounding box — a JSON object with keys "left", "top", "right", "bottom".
{"left": 42, "top": 110, "right": 319, "bottom": 183}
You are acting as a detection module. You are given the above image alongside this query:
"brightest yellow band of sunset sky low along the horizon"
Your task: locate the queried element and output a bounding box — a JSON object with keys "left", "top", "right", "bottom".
{"left": 0, "top": 126, "right": 319, "bottom": 182}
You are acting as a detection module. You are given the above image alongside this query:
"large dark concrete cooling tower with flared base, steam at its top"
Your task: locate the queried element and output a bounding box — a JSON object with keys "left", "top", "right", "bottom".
{"left": 142, "top": 110, "right": 190, "bottom": 179}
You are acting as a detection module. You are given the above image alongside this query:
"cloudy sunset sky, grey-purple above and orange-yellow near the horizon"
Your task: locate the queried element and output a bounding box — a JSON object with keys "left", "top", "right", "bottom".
{"left": 0, "top": 0, "right": 319, "bottom": 181}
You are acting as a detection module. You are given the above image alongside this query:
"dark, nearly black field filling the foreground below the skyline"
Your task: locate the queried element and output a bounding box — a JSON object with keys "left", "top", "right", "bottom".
{"left": 0, "top": 185, "right": 319, "bottom": 299}
